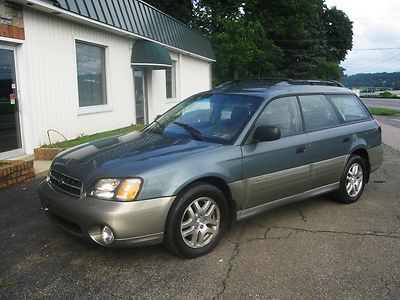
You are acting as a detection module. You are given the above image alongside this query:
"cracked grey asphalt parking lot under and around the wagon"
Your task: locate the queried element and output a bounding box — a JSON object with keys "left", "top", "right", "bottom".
{"left": 0, "top": 147, "right": 400, "bottom": 299}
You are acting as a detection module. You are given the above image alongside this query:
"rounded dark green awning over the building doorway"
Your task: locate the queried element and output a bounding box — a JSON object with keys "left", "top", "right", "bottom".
{"left": 131, "top": 40, "right": 172, "bottom": 70}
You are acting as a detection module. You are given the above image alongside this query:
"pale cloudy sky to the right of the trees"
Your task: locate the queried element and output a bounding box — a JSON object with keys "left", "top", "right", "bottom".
{"left": 325, "top": 0, "right": 400, "bottom": 75}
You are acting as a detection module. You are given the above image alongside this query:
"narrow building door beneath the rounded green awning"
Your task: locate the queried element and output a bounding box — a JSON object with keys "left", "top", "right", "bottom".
{"left": 133, "top": 70, "right": 148, "bottom": 124}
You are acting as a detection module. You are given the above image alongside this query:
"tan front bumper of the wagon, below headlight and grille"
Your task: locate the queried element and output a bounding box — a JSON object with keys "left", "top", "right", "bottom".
{"left": 39, "top": 180, "right": 175, "bottom": 247}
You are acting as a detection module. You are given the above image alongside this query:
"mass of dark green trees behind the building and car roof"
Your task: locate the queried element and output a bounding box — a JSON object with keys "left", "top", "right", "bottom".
{"left": 147, "top": 0, "right": 353, "bottom": 84}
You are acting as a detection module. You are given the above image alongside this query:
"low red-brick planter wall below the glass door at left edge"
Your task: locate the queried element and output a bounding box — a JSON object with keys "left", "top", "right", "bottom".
{"left": 0, "top": 160, "right": 35, "bottom": 190}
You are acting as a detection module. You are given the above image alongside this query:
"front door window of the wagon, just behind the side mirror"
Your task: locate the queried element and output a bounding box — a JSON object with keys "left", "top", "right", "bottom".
{"left": 257, "top": 97, "right": 301, "bottom": 137}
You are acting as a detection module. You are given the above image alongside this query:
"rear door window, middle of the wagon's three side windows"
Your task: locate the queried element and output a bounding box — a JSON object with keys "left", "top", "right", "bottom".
{"left": 299, "top": 95, "right": 339, "bottom": 131}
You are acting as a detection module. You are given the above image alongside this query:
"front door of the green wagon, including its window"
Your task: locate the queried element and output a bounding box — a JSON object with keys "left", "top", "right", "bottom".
{"left": 242, "top": 96, "right": 310, "bottom": 209}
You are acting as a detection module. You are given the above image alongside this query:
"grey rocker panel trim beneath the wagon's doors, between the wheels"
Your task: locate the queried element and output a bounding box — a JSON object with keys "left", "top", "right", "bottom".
{"left": 236, "top": 182, "right": 340, "bottom": 221}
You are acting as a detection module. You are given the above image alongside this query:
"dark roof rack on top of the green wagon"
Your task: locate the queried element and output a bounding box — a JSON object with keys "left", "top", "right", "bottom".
{"left": 216, "top": 78, "right": 344, "bottom": 88}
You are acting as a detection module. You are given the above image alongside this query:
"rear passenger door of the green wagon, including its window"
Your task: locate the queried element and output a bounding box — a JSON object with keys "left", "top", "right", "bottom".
{"left": 299, "top": 95, "right": 351, "bottom": 189}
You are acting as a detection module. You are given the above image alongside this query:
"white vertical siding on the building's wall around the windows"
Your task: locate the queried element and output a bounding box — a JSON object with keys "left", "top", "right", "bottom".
{"left": 17, "top": 9, "right": 211, "bottom": 153}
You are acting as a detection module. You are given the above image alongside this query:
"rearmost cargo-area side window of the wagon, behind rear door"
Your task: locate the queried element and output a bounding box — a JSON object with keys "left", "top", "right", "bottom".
{"left": 330, "top": 95, "right": 370, "bottom": 123}
